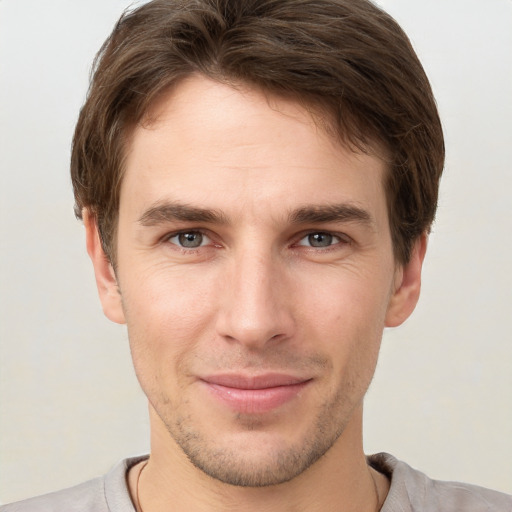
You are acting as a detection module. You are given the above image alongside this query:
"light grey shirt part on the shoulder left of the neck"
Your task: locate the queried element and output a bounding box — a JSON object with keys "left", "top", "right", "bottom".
{"left": 0, "top": 457, "right": 146, "bottom": 512}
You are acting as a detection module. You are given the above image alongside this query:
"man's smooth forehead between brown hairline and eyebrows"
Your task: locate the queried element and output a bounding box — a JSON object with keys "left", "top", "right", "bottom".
{"left": 120, "top": 76, "right": 386, "bottom": 226}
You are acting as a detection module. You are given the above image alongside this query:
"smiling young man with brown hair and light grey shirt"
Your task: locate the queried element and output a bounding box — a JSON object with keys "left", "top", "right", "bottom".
{"left": 5, "top": 0, "right": 512, "bottom": 512}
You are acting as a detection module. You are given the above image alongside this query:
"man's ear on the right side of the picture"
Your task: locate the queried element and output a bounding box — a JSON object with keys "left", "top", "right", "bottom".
{"left": 385, "top": 233, "right": 427, "bottom": 327}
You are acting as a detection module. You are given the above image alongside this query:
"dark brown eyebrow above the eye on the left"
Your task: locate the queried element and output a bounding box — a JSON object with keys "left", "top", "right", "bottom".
{"left": 138, "top": 202, "right": 227, "bottom": 227}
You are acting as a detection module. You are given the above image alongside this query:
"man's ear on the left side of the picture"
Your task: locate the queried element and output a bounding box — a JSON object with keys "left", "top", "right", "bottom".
{"left": 83, "top": 209, "right": 125, "bottom": 324}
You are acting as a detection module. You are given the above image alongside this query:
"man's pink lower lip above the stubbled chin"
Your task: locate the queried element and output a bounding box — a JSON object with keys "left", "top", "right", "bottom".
{"left": 205, "top": 381, "right": 310, "bottom": 414}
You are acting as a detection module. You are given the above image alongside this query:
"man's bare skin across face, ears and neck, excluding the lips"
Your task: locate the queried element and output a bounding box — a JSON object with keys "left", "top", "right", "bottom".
{"left": 85, "top": 76, "right": 426, "bottom": 512}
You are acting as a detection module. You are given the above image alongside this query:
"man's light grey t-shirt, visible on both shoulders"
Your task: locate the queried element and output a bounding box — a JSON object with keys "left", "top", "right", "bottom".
{"left": 0, "top": 453, "right": 512, "bottom": 512}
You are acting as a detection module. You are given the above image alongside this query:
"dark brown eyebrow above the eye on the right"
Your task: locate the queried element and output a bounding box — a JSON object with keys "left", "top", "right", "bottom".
{"left": 289, "top": 204, "right": 375, "bottom": 226}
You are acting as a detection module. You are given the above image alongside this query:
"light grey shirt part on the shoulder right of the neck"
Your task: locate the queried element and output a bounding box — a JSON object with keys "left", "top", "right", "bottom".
{"left": 368, "top": 453, "right": 512, "bottom": 512}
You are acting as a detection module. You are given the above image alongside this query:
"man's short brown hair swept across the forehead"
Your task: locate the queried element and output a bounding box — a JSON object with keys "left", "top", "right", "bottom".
{"left": 71, "top": 0, "right": 444, "bottom": 263}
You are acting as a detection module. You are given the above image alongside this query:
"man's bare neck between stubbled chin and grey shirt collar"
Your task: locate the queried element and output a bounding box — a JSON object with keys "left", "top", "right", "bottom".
{"left": 130, "top": 409, "right": 388, "bottom": 512}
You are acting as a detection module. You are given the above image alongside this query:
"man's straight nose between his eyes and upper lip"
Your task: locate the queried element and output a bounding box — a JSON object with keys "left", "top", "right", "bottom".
{"left": 217, "top": 246, "right": 295, "bottom": 350}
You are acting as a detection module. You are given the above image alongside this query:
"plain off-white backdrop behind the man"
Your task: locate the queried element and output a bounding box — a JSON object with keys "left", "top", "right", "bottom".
{"left": 0, "top": 0, "right": 512, "bottom": 503}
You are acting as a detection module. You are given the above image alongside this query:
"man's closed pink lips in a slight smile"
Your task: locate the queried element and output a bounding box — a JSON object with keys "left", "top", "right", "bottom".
{"left": 200, "top": 373, "right": 312, "bottom": 414}
